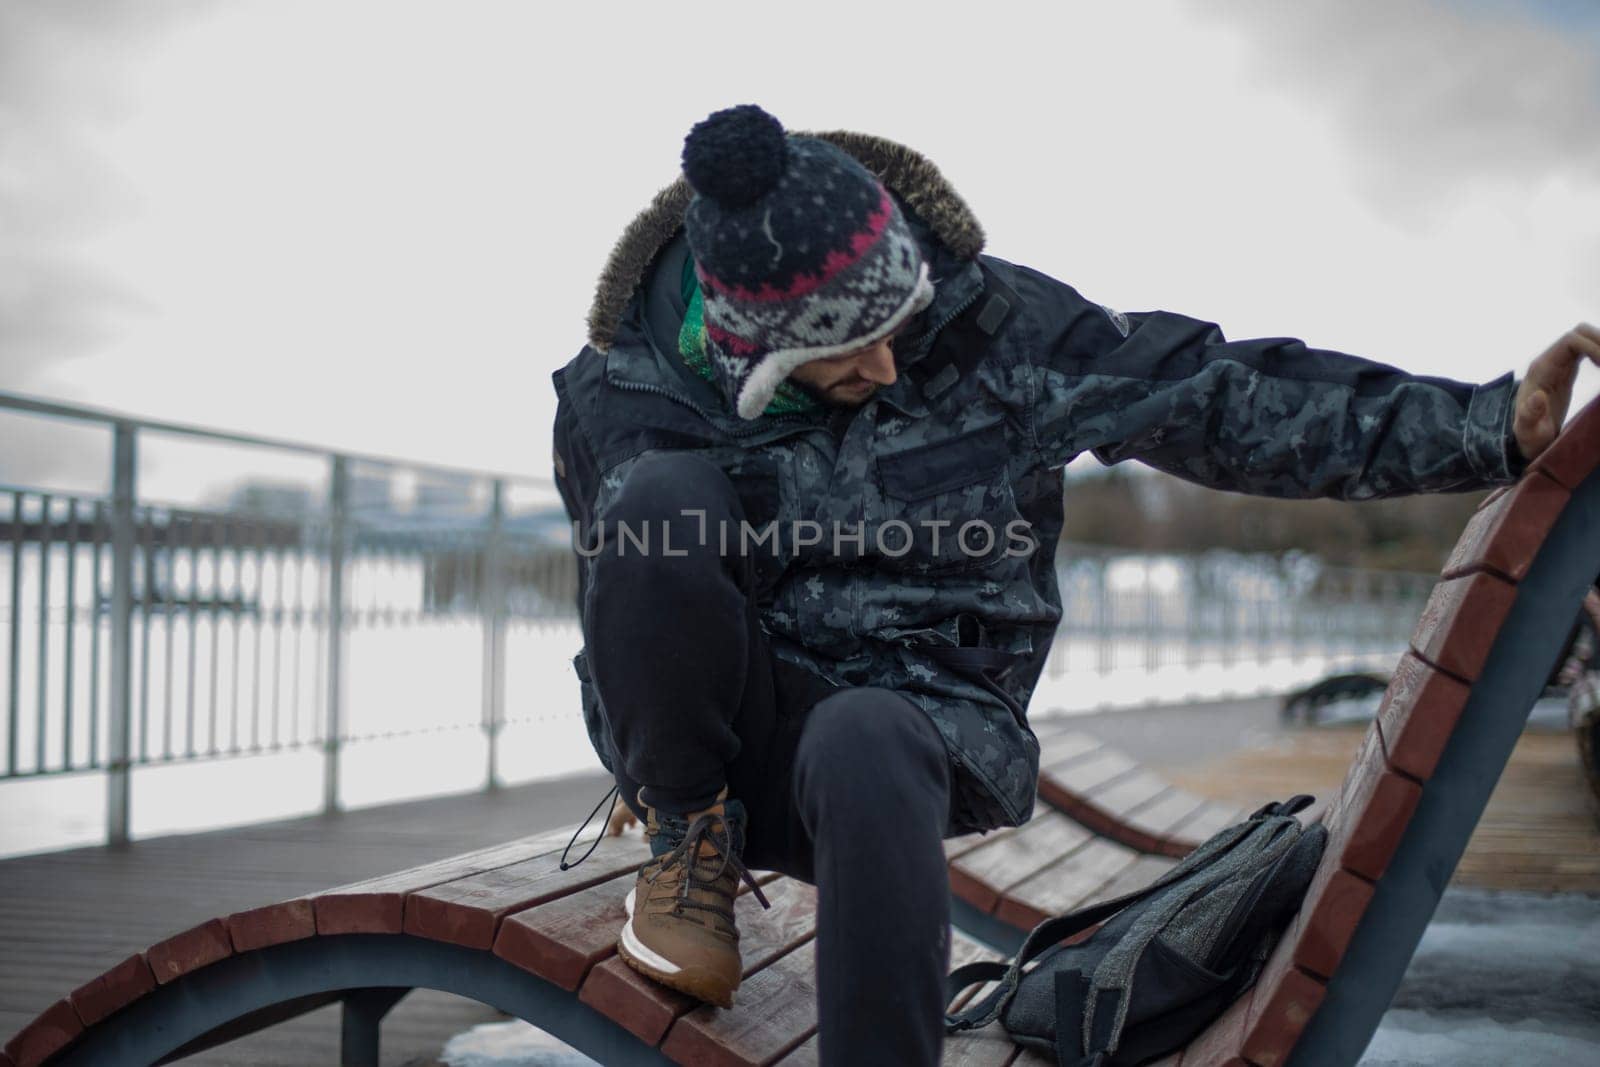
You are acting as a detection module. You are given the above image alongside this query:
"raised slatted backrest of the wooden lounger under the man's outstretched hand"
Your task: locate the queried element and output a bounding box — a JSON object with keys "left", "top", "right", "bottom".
{"left": 1166, "top": 402, "right": 1600, "bottom": 1067}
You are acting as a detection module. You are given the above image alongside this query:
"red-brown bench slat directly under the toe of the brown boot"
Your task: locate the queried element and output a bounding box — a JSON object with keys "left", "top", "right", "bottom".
{"left": 578, "top": 878, "right": 816, "bottom": 1045}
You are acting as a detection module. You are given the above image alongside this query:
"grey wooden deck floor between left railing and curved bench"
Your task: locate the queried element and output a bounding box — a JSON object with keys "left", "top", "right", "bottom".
{"left": 0, "top": 774, "right": 610, "bottom": 1067}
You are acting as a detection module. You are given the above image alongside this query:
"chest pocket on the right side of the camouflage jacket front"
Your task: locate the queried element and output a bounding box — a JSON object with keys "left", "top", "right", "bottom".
{"left": 869, "top": 419, "right": 1021, "bottom": 573}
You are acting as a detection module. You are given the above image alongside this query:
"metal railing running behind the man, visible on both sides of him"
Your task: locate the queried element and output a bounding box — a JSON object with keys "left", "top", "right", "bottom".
{"left": 0, "top": 394, "right": 1432, "bottom": 843}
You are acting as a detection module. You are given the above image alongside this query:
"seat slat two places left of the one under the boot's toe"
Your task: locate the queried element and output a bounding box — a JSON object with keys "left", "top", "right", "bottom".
{"left": 405, "top": 835, "right": 650, "bottom": 949}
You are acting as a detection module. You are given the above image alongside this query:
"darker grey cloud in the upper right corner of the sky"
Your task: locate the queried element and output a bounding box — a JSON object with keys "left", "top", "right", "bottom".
{"left": 1205, "top": 0, "right": 1600, "bottom": 227}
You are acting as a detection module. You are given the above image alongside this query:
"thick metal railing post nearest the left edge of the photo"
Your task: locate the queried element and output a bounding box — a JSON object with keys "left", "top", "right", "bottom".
{"left": 108, "top": 422, "right": 138, "bottom": 848}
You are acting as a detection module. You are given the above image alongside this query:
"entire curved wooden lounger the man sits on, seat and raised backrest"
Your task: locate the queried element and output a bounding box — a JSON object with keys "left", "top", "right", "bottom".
{"left": 12, "top": 403, "right": 1600, "bottom": 1067}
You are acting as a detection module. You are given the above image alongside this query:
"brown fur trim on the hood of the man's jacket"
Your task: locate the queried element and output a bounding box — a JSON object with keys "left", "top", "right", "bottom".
{"left": 589, "top": 130, "right": 984, "bottom": 352}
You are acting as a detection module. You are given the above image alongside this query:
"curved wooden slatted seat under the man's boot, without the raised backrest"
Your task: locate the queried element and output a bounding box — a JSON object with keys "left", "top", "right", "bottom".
{"left": 6, "top": 793, "right": 1173, "bottom": 1065}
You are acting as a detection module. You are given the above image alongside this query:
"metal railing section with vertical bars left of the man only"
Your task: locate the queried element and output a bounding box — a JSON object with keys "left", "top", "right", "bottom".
{"left": 0, "top": 394, "right": 578, "bottom": 843}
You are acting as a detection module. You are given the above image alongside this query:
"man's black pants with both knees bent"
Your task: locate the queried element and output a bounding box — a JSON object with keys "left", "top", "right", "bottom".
{"left": 584, "top": 453, "right": 950, "bottom": 1065}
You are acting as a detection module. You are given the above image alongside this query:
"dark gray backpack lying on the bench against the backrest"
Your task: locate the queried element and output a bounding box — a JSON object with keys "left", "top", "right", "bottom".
{"left": 944, "top": 795, "right": 1328, "bottom": 1067}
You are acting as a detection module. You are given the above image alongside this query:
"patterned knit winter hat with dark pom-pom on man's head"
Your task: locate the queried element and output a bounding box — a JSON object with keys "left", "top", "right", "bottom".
{"left": 683, "top": 104, "right": 933, "bottom": 419}
